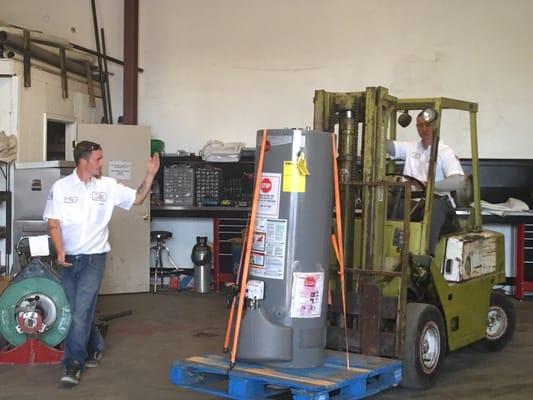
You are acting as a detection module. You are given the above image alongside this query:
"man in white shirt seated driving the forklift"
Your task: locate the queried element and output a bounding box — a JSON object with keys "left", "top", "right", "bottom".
{"left": 387, "top": 113, "right": 464, "bottom": 254}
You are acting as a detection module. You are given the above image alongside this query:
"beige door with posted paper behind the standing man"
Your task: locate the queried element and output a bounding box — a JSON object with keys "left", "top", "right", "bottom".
{"left": 77, "top": 124, "right": 150, "bottom": 294}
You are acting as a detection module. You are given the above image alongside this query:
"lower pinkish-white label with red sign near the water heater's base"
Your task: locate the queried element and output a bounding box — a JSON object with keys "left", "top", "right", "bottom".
{"left": 291, "top": 272, "right": 324, "bottom": 318}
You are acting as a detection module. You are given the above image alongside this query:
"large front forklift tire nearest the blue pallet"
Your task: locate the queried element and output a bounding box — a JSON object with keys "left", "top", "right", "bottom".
{"left": 400, "top": 303, "right": 446, "bottom": 389}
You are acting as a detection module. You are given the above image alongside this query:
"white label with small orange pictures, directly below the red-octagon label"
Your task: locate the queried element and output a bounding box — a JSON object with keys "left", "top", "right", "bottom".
{"left": 250, "top": 218, "right": 287, "bottom": 279}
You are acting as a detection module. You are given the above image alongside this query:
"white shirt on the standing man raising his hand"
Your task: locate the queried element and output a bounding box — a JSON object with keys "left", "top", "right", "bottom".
{"left": 43, "top": 170, "right": 136, "bottom": 254}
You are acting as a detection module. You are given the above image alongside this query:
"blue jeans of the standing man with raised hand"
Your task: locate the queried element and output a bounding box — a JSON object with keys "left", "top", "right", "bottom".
{"left": 60, "top": 253, "right": 107, "bottom": 369}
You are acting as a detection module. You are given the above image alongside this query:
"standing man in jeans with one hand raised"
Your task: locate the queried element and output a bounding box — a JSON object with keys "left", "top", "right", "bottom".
{"left": 44, "top": 141, "right": 160, "bottom": 385}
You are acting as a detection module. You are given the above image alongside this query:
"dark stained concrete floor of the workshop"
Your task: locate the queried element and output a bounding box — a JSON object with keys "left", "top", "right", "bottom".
{"left": 0, "top": 292, "right": 533, "bottom": 400}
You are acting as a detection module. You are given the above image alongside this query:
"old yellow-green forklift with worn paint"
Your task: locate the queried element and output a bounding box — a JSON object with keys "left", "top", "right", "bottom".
{"left": 314, "top": 87, "right": 515, "bottom": 389}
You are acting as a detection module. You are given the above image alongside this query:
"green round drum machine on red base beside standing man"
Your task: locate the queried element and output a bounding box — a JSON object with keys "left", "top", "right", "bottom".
{"left": 0, "top": 237, "right": 71, "bottom": 365}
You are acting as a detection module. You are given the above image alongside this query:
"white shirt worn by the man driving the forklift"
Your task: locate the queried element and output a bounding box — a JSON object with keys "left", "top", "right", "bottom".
{"left": 393, "top": 141, "right": 464, "bottom": 196}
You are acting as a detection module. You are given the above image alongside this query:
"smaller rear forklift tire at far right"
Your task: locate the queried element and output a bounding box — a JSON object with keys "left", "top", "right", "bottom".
{"left": 480, "top": 293, "right": 516, "bottom": 351}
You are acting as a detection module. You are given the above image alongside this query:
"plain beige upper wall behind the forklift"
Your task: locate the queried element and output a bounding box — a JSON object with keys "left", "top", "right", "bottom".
{"left": 0, "top": 0, "right": 533, "bottom": 158}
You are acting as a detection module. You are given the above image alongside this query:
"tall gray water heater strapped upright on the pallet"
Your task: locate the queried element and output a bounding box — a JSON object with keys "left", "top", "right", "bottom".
{"left": 237, "top": 129, "right": 333, "bottom": 368}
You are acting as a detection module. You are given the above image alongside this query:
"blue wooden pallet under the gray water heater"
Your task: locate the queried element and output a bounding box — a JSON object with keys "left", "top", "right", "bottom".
{"left": 170, "top": 351, "right": 402, "bottom": 400}
